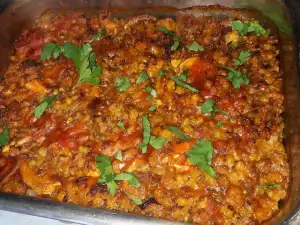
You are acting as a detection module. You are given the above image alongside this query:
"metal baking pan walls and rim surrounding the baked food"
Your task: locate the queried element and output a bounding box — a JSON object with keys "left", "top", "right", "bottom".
{"left": 0, "top": 0, "right": 300, "bottom": 225}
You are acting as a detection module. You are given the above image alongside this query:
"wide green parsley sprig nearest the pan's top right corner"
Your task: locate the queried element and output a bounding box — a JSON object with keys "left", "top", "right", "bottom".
{"left": 231, "top": 20, "right": 268, "bottom": 36}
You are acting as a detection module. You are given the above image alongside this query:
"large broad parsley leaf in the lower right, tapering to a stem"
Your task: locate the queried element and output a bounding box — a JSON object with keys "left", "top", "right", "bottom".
{"left": 186, "top": 140, "right": 216, "bottom": 177}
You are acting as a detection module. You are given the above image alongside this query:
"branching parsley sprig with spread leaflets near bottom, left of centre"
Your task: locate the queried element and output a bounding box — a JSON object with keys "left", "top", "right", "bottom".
{"left": 95, "top": 155, "right": 140, "bottom": 195}
